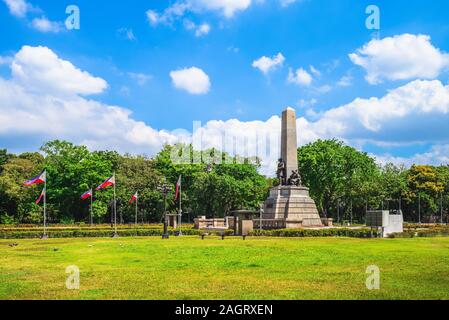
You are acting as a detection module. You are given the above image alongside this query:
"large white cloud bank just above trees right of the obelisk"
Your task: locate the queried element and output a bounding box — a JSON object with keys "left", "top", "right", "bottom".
{"left": 302, "top": 80, "right": 449, "bottom": 144}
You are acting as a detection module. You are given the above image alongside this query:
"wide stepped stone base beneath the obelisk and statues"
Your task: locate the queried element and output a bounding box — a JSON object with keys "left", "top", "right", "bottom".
{"left": 263, "top": 186, "right": 323, "bottom": 229}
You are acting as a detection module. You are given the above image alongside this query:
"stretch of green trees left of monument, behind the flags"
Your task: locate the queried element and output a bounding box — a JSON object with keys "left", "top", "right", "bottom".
{"left": 0, "top": 140, "right": 270, "bottom": 224}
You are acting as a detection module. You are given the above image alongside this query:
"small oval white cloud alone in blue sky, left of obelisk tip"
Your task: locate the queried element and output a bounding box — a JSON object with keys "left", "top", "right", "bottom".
{"left": 170, "top": 67, "right": 211, "bottom": 95}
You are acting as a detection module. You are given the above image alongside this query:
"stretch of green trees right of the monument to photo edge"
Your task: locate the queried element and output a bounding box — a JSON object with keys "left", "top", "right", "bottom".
{"left": 298, "top": 140, "right": 449, "bottom": 223}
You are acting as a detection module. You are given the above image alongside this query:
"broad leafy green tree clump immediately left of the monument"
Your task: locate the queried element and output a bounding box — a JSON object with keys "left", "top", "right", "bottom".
{"left": 155, "top": 145, "right": 269, "bottom": 217}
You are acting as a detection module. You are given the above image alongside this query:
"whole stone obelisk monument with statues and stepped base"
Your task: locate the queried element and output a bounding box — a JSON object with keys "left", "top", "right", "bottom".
{"left": 263, "top": 108, "right": 323, "bottom": 229}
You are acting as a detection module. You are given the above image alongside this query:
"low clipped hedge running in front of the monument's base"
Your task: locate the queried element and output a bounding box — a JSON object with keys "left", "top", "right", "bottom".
{"left": 250, "top": 229, "right": 377, "bottom": 238}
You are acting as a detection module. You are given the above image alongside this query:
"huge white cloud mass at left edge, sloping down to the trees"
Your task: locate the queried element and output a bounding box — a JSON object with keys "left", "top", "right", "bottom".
{"left": 0, "top": 46, "right": 185, "bottom": 154}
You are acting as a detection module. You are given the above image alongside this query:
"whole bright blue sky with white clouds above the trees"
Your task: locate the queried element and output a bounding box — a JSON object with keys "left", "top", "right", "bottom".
{"left": 0, "top": 0, "right": 449, "bottom": 173}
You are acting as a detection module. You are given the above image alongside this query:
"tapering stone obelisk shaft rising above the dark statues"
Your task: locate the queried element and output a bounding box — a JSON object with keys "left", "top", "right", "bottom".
{"left": 281, "top": 108, "right": 298, "bottom": 179}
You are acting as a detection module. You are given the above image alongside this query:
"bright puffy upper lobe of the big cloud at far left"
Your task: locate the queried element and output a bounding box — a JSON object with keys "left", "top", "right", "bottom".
{"left": 11, "top": 46, "right": 107, "bottom": 95}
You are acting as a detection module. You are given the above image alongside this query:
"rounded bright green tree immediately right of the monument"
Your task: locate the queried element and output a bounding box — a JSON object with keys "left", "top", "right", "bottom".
{"left": 298, "top": 140, "right": 378, "bottom": 222}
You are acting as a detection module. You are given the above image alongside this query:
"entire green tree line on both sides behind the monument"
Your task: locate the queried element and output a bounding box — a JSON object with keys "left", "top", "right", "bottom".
{"left": 0, "top": 140, "right": 449, "bottom": 224}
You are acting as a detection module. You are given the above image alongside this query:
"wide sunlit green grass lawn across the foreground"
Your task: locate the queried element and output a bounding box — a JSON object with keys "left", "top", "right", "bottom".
{"left": 0, "top": 237, "right": 449, "bottom": 300}
